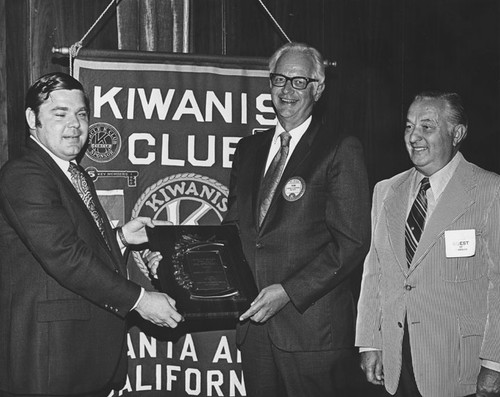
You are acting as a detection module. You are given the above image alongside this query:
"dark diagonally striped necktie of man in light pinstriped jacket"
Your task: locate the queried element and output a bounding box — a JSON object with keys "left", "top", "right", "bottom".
{"left": 405, "top": 178, "right": 431, "bottom": 266}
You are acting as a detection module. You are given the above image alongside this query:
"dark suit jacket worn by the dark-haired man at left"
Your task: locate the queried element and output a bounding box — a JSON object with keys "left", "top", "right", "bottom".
{"left": 0, "top": 141, "right": 140, "bottom": 395}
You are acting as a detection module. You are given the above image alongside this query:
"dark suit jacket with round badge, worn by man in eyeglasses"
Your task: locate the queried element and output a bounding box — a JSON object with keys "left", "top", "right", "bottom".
{"left": 225, "top": 118, "right": 370, "bottom": 351}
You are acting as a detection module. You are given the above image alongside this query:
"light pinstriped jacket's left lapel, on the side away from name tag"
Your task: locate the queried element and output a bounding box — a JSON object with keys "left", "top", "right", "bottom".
{"left": 384, "top": 171, "right": 412, "bottom": 274}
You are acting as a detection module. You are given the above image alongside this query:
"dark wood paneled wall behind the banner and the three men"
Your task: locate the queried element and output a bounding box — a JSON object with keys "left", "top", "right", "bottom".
{"left": 0, "top": 0, "right": 500, "bottom": 184}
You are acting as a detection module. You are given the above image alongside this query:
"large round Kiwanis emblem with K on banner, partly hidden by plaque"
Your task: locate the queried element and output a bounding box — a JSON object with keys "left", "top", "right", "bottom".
{"left": 132, "top": 173, "right": 228, "bottom": 267}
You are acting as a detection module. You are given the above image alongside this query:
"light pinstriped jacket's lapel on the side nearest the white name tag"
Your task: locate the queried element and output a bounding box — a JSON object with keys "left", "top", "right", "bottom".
{"left": 411, "top": 159, "right": 475, "bottom": 270}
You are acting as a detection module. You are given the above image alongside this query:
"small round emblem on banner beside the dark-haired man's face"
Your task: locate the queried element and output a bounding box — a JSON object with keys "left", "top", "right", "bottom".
{"left": 85, "top": 123, "right": 122, "bottom": 163}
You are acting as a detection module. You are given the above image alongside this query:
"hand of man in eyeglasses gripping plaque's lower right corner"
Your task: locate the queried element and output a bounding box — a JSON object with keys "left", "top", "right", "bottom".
{"left": 240, "top": 284, "right": 290, "bottom": 323}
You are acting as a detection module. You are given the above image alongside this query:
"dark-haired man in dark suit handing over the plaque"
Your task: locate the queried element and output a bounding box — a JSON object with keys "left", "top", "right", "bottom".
{"left": 0, "top": 73, "right": 182, "bottom": 396}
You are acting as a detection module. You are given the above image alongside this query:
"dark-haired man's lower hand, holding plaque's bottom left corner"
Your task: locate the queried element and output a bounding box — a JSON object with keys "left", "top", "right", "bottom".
{"left": 135, "top": 291, "right": 184, "bottom": 328}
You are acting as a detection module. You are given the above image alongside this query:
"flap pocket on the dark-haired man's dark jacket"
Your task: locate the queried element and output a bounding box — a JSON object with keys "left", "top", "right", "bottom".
{"left": 37, "top": 299, "right": 90, "bottom": 322}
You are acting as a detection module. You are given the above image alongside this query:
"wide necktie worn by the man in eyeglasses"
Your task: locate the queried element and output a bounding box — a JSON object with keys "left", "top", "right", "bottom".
{"left": 259, "top": 131, "right": 291, "bottom": 226}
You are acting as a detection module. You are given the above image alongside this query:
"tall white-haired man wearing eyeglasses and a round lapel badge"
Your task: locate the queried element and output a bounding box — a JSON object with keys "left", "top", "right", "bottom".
{"left": 225, "top": 43, "right": 370, "bottom": 397}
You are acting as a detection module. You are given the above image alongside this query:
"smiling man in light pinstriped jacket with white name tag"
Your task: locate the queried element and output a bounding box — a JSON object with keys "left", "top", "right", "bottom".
{"left": 356, "top": 92, "right": 500, "bottom": 397}
